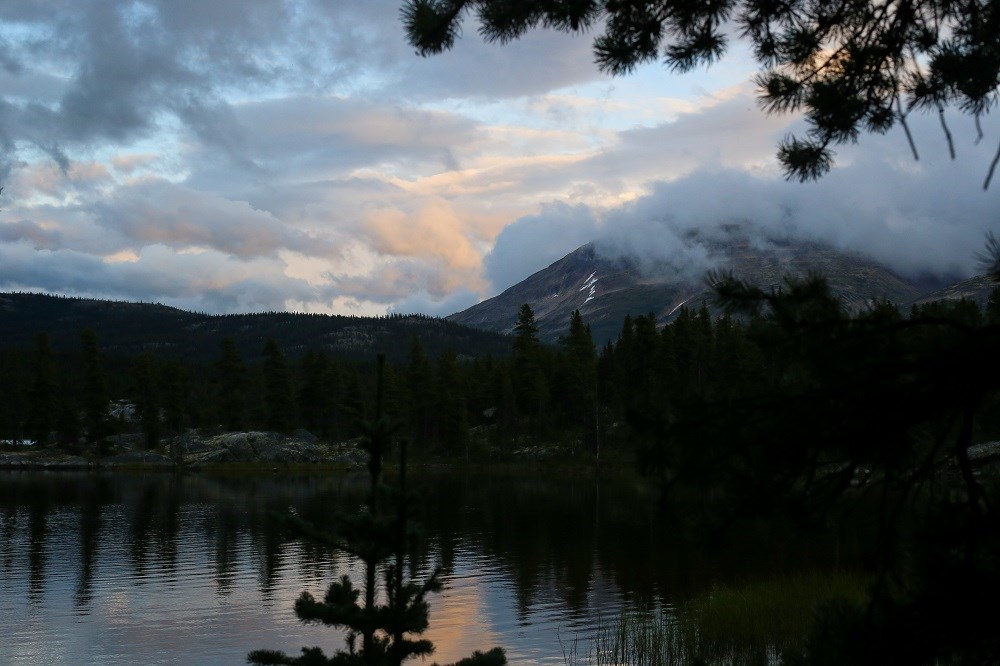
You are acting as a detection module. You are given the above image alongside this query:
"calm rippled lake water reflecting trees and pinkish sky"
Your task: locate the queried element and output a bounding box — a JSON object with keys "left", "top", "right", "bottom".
{"left": 0, "top": 472, "right": 851, "bottom": 664}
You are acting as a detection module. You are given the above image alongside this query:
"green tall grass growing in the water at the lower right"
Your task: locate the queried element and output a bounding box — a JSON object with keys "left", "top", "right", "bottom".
{"left": 563, "top": 572, "right": 869, "bottom": 666}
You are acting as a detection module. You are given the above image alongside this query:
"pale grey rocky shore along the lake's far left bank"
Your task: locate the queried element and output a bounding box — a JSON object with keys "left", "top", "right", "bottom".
{"left": 0, "top": 431, "right": 366, "bottom": 470}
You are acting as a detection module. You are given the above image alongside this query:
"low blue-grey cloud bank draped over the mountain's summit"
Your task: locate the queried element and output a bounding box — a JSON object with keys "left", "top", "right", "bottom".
{"left": 485, "top": 108, "right": 1000, "bottom": 291}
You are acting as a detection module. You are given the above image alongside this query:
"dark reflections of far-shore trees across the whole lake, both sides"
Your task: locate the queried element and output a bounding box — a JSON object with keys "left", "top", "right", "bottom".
{"left": 0, "top": 466, "right": 865, "bottom": 644}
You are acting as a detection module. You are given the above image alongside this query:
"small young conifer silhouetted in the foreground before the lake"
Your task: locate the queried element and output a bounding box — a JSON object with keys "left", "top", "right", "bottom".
{"left": 248, "top": 356, "right": 507, "bottom": 666}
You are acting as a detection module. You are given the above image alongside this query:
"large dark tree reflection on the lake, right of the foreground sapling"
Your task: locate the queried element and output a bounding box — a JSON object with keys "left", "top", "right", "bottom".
{"left": 418, "top": 476, "right": 864, "bottom": 622}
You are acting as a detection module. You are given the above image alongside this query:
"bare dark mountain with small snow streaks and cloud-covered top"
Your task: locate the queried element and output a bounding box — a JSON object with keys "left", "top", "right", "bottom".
{"left": 446, "top": 226, "right": 989, "bottom": 345}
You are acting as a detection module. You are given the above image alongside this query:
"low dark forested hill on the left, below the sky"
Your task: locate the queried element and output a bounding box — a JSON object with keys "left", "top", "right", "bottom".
{"left": 0, "top": 293, "right": 510, "bottom": 361}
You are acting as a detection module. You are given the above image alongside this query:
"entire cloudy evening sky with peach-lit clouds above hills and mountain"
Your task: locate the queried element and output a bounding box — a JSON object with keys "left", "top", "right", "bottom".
{"left": 0, "top": 0, "right": 1000, "bottom": 315}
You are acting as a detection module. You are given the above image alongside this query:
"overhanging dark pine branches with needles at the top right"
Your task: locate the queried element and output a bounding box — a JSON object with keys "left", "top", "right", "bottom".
{"left": 402, "top": 0, "right": 1000, "bottom": 189}
